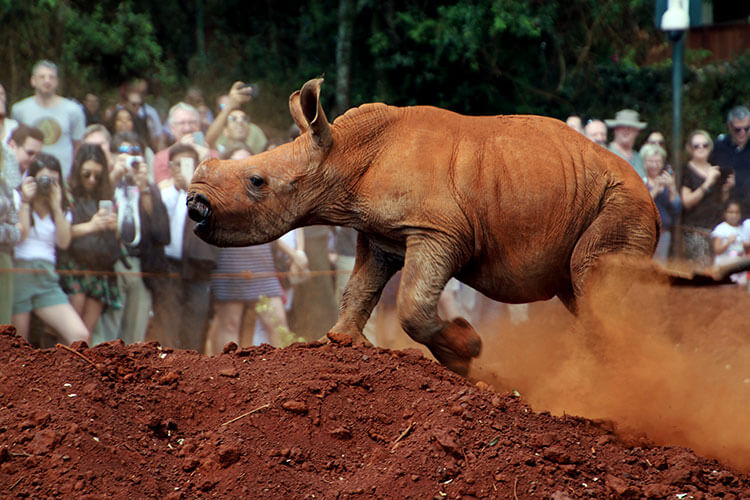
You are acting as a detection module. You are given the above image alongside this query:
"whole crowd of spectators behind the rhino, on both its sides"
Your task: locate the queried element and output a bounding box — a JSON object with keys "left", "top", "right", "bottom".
{"left": 0, "top": 61, "right": 750, "bottom": 354}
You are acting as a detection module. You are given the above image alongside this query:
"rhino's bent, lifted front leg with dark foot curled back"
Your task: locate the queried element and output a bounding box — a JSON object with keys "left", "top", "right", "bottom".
{"left": 397, "top": 240, "right": 482, "bottom": 376}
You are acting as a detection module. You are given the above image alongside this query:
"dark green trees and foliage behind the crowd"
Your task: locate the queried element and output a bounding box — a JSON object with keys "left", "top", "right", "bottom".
{"left": 0, "top": 0, "right": 750, "bottom": 144}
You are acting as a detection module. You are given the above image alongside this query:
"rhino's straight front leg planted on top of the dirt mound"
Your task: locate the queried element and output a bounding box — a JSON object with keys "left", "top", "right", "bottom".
{"left": 331, "top": 233, "right": 403, "bottom": 342}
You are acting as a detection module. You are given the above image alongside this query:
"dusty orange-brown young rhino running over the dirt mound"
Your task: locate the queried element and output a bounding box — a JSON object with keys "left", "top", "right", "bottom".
{"left": 188, "top": 79, "right": 659, "bottom": 375}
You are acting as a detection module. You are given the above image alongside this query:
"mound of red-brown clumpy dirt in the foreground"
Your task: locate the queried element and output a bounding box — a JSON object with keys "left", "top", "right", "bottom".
{"left": 0, "top": 328, "right": 750, "bottom": 500}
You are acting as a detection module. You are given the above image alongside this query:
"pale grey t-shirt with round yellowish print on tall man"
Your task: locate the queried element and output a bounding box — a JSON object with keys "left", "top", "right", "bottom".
{"left": 11, "top": 96, "right": 86, "bottom": 179}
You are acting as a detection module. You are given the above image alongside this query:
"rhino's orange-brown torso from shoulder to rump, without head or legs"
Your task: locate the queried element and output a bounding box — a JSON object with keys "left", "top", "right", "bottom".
{"left": 336, "top": 104, "right": 658, "bottom": 302}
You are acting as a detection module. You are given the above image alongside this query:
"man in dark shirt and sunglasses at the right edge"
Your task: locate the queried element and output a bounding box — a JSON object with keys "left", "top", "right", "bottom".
{"left": 709, "top": 106, "right": 750, "bottom": 214}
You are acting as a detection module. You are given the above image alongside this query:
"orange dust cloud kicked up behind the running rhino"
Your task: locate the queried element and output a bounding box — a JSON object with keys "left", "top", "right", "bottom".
{"left": 472, "top": 264, "right": 750, "bottom": 471}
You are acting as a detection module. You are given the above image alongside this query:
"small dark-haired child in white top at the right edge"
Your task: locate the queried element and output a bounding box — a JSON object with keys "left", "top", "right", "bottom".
{"left": 711, "top": 200, "right": 750, "bottom": 285}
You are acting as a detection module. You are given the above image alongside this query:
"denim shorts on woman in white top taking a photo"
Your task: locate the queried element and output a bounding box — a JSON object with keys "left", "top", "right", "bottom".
{"left": 13, "top": 260, "right": 69, "bottom": 314}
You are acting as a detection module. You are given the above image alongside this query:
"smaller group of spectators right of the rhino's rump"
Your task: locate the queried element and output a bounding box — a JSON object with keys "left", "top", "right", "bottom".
{"left": 566, "top": 105, "right": 750, "bottom": 276}
